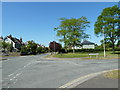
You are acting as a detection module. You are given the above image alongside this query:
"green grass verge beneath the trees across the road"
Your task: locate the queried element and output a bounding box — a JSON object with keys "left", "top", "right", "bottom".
{"left": 52, "top": 51, "right": 118, "bottom": 59}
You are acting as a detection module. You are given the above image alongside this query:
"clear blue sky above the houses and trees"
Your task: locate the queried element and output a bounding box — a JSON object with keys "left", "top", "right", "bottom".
{"left": 2, "top": 2, "right": 118, "bottom": 46}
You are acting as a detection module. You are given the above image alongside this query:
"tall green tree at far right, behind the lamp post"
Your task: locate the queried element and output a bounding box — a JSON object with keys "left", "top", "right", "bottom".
{"left": 94, "top": 5, "right": 120, "bottom": 53}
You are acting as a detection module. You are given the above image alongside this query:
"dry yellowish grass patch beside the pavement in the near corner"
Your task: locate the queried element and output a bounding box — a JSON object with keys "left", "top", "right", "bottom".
{"left": 103, "top": 70, "right": 120, "bottom": 79}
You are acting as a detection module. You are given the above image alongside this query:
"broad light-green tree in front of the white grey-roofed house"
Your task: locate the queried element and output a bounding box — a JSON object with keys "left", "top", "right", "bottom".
{"left": 54, "top": 16, "right": 90, "bottom": 53}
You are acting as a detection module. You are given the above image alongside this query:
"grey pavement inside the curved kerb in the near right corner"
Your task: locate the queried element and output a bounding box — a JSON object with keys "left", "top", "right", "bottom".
{"left": 74, "top": 74, "right": 118, "bottom": 88}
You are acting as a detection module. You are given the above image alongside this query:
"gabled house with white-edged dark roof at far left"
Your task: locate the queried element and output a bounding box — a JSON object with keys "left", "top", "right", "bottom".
{"left": 4, "top": 35, "right": 24, "bottom": 50}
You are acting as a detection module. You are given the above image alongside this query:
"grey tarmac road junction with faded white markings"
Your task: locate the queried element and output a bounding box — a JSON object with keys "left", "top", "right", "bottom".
{"left": 2, "top": 54, "right": 118, "bottom": 88}
